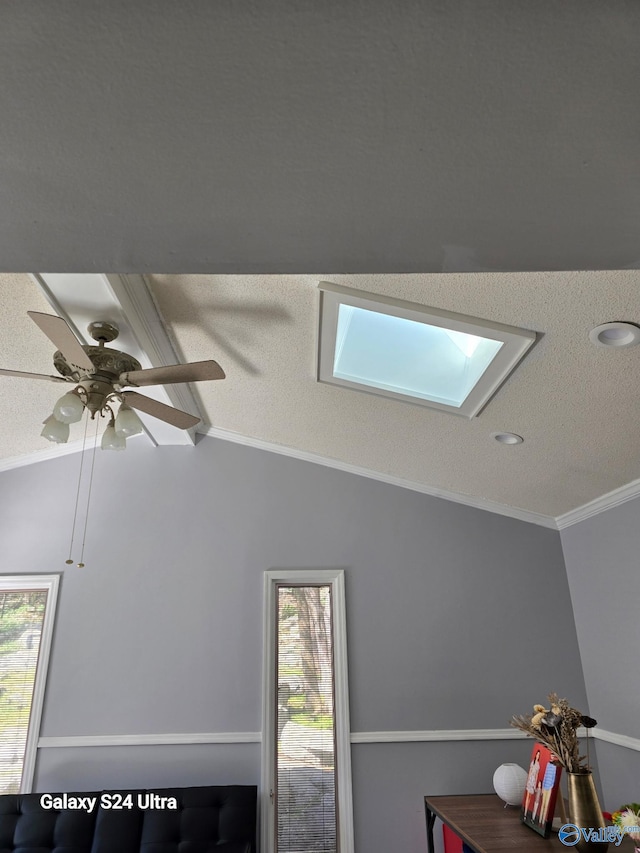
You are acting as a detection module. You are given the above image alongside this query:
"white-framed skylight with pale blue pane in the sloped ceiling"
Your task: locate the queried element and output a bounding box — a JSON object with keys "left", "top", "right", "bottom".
{"left": 318, "top": 282, "right": 535, "bottom": 417}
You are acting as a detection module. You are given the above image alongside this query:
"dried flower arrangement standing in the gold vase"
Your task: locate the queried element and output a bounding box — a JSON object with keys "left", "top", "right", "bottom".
{"left": 509, "top": 693, "right": 596, "bottom": 773}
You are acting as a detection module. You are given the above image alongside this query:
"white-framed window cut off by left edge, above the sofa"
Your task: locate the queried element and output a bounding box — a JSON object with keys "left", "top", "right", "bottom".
{"left": 0, "top": 575, "right": 58, "bottom": 794}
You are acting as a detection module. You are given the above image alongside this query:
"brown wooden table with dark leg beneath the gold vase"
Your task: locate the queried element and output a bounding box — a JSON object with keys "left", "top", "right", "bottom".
{"left": 424, "top": 794, "right": 633, "bottom": 853}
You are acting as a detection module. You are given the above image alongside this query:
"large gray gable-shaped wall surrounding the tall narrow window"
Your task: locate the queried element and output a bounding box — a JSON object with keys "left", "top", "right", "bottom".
{"left": 0, "top": 439, "right": 586, "bottom": 853}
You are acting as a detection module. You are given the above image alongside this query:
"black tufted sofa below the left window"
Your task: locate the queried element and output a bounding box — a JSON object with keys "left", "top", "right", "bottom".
{"left": 0, "top": 785, "right": 257, "bottom": 853}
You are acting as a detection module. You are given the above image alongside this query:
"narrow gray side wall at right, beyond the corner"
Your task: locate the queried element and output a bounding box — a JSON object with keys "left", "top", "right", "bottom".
{"left": 561, "top": 498, "right": 640, "bottom": 809}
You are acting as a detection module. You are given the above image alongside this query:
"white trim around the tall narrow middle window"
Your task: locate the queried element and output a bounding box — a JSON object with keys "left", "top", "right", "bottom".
{"left": 260, "top": 569, "right": 354, "bottom": 853}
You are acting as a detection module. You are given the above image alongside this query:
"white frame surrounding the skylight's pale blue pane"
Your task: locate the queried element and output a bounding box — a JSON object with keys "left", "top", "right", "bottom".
{"left": 316, "top": 281, "right": 537, "bottom": 419}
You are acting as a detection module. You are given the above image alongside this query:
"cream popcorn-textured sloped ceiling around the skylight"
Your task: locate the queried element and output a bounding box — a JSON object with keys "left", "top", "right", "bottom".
{"left": 0, "top": 270, "right": 640, "bottom": 517}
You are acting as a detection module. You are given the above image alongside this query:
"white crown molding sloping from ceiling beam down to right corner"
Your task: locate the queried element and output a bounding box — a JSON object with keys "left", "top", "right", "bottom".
{"left": 197, "top": 427, "right": 557, "bottom": 530}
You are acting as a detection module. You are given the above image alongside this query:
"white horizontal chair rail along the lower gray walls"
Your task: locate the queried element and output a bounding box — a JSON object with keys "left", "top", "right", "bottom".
{"left": 38, "top": 728, "right": 640, "bottom": 752}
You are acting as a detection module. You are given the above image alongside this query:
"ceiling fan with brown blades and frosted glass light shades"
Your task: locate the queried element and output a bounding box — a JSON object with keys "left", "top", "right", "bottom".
{"left": 0, "top": 311, "right": 225, "bottom": 450}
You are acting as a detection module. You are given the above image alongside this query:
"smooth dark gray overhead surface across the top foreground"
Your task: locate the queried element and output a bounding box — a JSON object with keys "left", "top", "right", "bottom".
{"left": 0, "top": 0, "right": 640, "bottom": 275}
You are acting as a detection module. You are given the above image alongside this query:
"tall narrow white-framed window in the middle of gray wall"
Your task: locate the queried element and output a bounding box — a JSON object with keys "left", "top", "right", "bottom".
{"left": 261, "top": 571, "right": 353, "bottom": 853}
